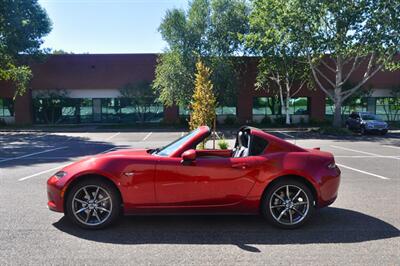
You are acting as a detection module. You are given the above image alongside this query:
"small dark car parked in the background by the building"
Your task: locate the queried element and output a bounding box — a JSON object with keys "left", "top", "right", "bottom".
{"left": 346, "top": 112, "right": 388, "bottom": 135}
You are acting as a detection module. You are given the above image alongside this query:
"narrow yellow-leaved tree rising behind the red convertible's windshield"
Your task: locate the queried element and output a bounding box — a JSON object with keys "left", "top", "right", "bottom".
{"left": 189, "top": 60, "right": 217, "bottom": 130}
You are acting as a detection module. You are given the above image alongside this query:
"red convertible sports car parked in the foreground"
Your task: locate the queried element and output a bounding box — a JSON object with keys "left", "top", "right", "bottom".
{"left": 47, "top": 126, "right": 340, "bottom": 229}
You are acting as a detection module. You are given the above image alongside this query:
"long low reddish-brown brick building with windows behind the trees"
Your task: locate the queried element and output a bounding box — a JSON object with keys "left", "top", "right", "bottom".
{"left": 0, "top": 54, "right": 400, "bottom": 124}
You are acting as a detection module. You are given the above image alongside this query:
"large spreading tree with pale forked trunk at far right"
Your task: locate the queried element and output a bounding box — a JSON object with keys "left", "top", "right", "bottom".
{"left": 291, "top": 0, "right": 400, "bottom": 127}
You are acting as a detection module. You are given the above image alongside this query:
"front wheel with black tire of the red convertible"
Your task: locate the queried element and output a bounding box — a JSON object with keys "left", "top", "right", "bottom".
{"left": 65, "top": 178, "right": 121, "bottom": 229}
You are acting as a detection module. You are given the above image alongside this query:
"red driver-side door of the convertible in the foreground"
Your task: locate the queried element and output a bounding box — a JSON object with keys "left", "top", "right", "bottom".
{"left": 155, "top": 157, "right": 261, "bottom": 206}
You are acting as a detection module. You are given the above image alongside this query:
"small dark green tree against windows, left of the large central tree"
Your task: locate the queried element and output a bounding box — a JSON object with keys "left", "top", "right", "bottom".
{"left": 119, "top": 80, "right": 156, "bottom": 123}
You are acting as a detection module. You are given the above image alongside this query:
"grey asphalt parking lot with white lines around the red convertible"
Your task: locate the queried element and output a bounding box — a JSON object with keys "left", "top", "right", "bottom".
{"left": 0, "top": 130, "right": 400, "bottom": 265}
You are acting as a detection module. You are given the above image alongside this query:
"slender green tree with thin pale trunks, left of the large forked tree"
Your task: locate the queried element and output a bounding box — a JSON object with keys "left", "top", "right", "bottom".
{"left": 246, "top": 0, "right": 309, "bottom": 124}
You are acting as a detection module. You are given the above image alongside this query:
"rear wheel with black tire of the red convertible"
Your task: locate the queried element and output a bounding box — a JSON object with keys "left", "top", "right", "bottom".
{"left": 261, "top": 178, "right": 315, "bottom": 229}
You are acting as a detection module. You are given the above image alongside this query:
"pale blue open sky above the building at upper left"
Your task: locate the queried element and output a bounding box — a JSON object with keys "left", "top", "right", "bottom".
{"left": 39, "top": 0, "right": 187, "bottom": 54}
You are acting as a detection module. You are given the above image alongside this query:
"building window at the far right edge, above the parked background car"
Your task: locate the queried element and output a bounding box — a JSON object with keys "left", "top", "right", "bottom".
{"left": 375, "top": 97, "right": 400, "bottom": 121}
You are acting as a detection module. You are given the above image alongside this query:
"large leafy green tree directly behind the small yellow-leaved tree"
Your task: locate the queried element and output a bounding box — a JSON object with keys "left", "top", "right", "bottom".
{"left": 153, "top": 0, "right": 249, "bottom": 109}
